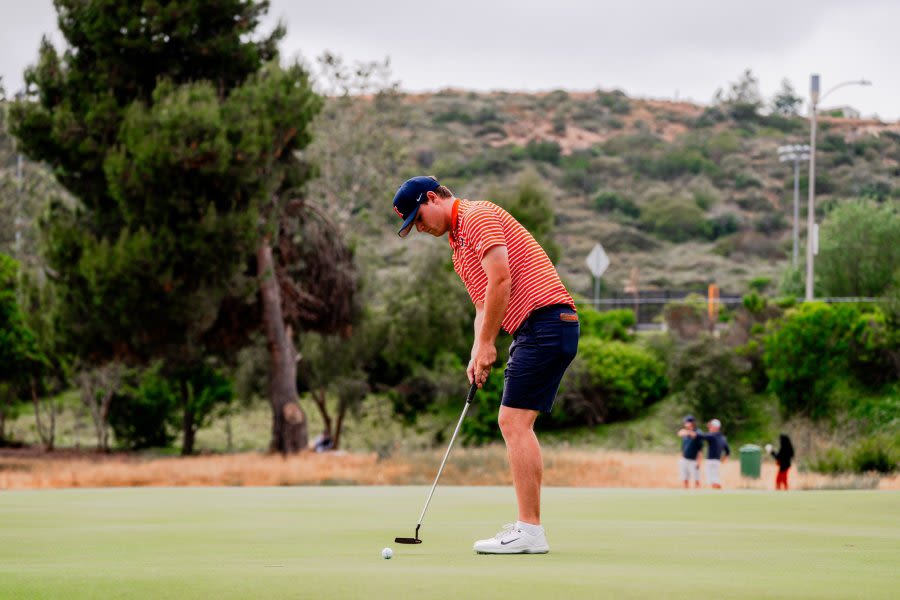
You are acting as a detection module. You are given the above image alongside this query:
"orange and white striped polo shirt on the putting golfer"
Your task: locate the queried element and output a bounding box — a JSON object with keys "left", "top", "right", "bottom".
{"left": 448, "top": 200, "right": 575, "bottom": 333}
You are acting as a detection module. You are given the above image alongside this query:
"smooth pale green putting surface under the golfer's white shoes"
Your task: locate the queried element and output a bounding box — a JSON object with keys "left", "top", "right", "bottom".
{"left": 0, "top": 487, "right": 900, "bottom": 600}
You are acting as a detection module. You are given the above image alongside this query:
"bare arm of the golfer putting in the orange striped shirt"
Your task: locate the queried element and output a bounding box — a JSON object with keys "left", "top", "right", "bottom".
{"left": 468, "top": 246, "right": 511, "bottom": 387}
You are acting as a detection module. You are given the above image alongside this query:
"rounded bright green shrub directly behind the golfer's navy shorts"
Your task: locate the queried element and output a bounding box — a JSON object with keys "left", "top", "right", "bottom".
{"left": 557, "top": 337, "right": 668, "bottom": 425}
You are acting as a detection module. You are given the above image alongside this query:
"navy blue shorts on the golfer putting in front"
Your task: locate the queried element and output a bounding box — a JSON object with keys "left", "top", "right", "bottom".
{"left": 502, "top": 304, "right": 579, "bottom": 413}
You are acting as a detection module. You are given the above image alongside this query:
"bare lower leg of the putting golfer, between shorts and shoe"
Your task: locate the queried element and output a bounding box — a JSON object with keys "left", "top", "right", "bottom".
{"left": 498, "top": 406, "right": 544, "bottom": 525}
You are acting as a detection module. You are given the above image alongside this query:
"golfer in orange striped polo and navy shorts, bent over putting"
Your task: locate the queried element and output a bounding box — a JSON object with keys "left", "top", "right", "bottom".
{"left": 394, "top": 177, "right": 579, "bottom": 554}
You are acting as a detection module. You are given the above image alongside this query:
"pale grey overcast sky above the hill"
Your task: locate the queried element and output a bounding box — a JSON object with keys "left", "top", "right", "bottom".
{"left": 0, "top": 0, "right": 900, "bottom": 121}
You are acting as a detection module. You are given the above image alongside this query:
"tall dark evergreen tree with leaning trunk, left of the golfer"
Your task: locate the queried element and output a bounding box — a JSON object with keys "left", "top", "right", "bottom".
{"left": 12, "top": 0, "right": 356, "bottom": 453}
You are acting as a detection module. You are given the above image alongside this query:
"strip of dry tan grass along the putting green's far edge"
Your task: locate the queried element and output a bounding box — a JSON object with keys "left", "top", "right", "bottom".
{"left": 0, "top": 446, "right": 900, "bottom": 490}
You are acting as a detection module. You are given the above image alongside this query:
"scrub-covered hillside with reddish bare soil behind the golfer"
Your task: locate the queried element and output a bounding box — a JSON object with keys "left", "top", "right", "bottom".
{"left": 358, "top": 74, "right": 900, "bottom": 296}
